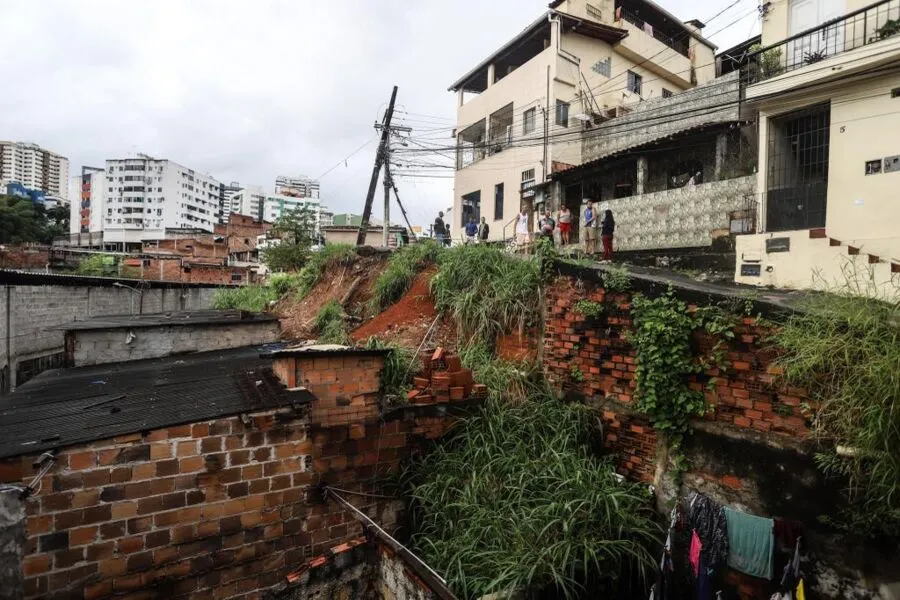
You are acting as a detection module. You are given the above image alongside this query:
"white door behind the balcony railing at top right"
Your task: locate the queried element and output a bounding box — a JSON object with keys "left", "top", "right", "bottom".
{"left": 786, "top": 0, "right": 844, "bottom": 69}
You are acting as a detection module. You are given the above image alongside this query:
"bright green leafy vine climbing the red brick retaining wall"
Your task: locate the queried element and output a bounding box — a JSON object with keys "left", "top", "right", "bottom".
{"left": 628, "top": 290, "right": 734, "bottom": 447}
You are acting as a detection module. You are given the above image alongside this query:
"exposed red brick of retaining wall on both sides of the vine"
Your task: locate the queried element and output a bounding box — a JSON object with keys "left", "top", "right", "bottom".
{"left": 544, "top": 277, "right": 808, "bottom": 481}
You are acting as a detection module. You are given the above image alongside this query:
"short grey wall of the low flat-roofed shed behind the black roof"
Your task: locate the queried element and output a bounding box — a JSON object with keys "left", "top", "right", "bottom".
{"left": 69, "top": 321, "right": 281, "bottom": 367}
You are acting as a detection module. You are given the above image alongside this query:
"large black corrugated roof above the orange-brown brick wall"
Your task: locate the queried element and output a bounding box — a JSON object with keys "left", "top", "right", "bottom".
{"left": 0, "top": 346, "right": 313, "bottom": 458}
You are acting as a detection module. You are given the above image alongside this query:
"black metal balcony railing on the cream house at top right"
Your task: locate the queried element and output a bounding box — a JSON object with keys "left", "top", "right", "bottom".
{"left": 744, "top": 0, "right": 900, "bottom": 84}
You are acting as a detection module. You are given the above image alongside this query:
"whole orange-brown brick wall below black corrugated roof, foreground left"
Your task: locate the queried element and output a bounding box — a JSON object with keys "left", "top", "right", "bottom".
{"left": 0, "top": 392, "right": 453, "bottom": 599}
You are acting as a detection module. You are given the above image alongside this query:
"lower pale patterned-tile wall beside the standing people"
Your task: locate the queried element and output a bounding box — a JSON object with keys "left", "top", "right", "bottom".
{"left": 601, "top": 175, "right": 756, "bottom": 250}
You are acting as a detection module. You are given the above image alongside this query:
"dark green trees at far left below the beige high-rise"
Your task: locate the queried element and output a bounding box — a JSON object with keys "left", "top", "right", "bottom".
{"left": 0, "top": 195, "right": 69, "bottom": 244}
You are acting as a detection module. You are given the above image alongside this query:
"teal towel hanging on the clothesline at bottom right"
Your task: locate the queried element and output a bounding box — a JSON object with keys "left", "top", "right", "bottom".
{"left": 725, "top": 506, "right": 775, "bottom": 579}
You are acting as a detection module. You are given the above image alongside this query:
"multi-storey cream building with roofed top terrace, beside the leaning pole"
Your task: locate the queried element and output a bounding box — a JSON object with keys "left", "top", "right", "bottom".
{"left": 448, "top": 0, "right": 715, "bottom": 239}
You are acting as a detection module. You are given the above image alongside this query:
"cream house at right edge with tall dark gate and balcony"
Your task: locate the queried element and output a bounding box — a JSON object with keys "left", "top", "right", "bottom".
{"left": 735, "top": 0, "right": 900, "bottom": 298}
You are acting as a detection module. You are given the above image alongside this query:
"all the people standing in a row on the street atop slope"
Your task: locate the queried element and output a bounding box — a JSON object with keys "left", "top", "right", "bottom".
{"left": 434, "top": 202, "right": 616, "bottom": 260}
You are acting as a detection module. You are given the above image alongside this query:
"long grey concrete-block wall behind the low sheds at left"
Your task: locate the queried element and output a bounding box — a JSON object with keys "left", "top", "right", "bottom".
{"left": 0, "top": 285, "right": 215, "bottom": 393}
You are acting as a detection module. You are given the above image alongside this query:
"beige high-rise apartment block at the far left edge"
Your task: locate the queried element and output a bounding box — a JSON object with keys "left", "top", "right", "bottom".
{"left": 0, "top": 141, "right": 69, "bottom": 202}
